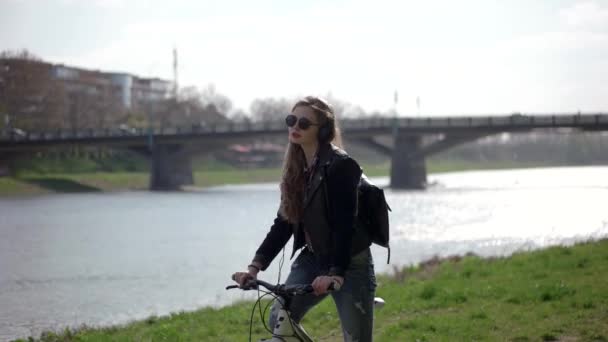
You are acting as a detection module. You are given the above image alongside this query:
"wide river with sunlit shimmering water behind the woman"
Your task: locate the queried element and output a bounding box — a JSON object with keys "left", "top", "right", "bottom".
{"left": 0, "top": 167, "right": 608, "bottom": 341}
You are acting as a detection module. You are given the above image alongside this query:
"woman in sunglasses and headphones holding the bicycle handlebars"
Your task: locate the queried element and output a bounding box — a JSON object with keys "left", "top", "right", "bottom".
{"left": 232, "top": 96, "right": 376, "bottom": 342}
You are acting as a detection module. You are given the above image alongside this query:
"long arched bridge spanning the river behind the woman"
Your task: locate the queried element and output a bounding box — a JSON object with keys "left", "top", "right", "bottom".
{"left": 0, "top": 113, "right": 608, "bottom": 190}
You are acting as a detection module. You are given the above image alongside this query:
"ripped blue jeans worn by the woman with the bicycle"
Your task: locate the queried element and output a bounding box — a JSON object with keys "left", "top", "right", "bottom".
{"left": 269, "top": 248, "right": 376, "bottom": 342}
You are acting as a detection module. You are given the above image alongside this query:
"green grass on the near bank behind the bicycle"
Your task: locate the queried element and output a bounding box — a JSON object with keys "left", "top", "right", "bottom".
{"left": 10, "top": 240, "right": 608, "bottom": 342}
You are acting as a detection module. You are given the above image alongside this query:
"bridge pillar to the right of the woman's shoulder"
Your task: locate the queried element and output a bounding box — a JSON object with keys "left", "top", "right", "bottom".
{"left": 391, "top": 133, "right": 426, "bottom": 189}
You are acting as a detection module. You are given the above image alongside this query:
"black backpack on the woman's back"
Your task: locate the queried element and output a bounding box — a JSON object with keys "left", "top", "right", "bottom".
{"left": 324, "top": 164, "right": 392, "bottom": 264}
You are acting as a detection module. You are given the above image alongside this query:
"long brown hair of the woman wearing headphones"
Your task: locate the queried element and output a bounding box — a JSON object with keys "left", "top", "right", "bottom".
{"left": 279, "top": 96, "right": 342, "bottom": 223}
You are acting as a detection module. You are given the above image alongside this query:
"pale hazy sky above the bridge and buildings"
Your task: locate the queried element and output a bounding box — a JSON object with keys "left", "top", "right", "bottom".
{"left": 0, "top": 0, "right": 608, "bottom": 116}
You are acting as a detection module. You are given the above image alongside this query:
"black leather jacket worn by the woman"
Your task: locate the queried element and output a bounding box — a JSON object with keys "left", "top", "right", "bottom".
{"left": 253, "top": 144, "right": 371, "bottom": 276}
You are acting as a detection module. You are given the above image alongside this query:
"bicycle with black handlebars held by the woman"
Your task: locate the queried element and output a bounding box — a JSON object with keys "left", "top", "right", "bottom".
{"left": 226, "top": 279, "right": 384, "bottom": 342}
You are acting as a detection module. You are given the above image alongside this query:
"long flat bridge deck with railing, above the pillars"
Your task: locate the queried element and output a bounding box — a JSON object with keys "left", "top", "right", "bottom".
{"left": 0, "top": 113, "right": 608, "bottom": 146}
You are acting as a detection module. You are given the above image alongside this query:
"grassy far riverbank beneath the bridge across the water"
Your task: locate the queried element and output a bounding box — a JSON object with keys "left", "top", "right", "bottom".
{"left": 0, "top": 160, "right": 547, "bottom": 196}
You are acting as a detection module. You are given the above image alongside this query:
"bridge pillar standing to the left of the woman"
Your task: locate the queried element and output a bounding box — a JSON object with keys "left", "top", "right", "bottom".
{"left": 150, "top": 145, "right": 194, "bottom": 190}
